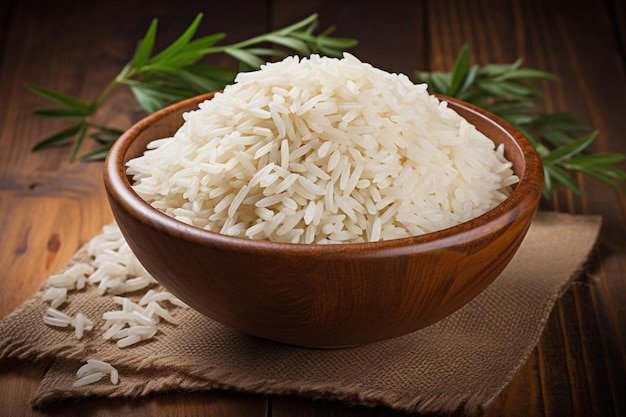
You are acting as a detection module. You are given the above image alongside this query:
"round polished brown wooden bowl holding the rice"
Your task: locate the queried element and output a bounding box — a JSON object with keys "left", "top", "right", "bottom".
{"left": 104, "top": 94, "right": 543, "bottom": 347}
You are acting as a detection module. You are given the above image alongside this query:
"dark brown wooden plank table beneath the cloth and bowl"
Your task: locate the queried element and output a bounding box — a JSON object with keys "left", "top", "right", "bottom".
{"left": 0, "top": 0, "right": 626, "bottom": 417}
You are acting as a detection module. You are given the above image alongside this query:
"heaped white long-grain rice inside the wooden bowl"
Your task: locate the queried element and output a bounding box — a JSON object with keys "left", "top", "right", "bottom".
{"left": 127, "top": 54, "right": 518, "bottom": 243}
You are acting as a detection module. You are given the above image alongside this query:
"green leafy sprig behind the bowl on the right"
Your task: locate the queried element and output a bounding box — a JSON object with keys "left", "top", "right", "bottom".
{"left": 416, "top": 45, "right": 626, "bottom": 199}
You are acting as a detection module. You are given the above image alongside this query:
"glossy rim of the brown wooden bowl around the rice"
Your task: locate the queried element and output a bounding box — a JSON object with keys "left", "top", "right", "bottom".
{"left": 103, "top": 92, "right": 544, "bottom": 257}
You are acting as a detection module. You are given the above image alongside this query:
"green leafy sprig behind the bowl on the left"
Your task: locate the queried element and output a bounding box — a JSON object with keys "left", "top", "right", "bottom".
{"left": 26, "top": 14, "right": 357, "bottom": 161}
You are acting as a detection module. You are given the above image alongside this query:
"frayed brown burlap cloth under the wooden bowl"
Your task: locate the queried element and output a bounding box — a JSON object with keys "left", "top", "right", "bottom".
{"left": 0, "top": 212, "right": 601, "bottom": 412}
